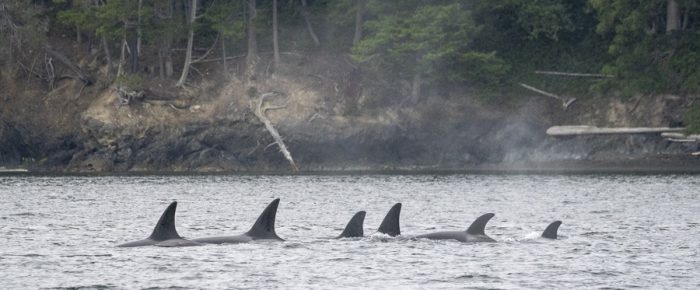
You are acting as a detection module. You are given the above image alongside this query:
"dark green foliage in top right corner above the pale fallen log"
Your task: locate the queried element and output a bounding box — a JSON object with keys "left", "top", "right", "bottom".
{"left": 589, "top": 0, "right": 700, "bottom": 94}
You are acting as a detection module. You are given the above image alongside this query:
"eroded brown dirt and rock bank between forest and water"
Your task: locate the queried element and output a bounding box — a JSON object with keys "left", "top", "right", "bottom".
{"left": 0, "top": 50, "right": 700, "bottom": 172}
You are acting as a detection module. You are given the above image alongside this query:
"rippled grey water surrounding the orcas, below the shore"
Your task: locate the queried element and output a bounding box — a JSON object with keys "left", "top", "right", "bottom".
{"left": 0, "top": 175, "right": 700, "bottom": 289}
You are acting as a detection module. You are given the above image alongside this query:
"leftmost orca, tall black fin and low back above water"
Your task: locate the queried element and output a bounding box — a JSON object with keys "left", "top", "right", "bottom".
{"left": 117, "top": 201, "right": 202, "bottom": 247}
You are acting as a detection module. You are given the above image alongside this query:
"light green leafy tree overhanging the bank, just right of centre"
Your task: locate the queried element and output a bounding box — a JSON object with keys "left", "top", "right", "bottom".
{"left": 353, "top": 1, "right": 508, "bottom": 88}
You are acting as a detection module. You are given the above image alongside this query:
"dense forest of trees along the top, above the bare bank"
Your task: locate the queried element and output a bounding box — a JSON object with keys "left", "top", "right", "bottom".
{"left": 0, "top": 0, "right": 700, "bottom": 94}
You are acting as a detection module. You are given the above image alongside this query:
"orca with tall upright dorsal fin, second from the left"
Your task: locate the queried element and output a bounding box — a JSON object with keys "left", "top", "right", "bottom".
{"left": 192, "top": 198, "right": 284, "bottom": 244}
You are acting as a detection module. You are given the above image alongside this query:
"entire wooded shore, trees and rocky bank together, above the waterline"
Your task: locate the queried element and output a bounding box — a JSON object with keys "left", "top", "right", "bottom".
{"left": 0, "top": 0, "right": 700, "bottom": 174}
